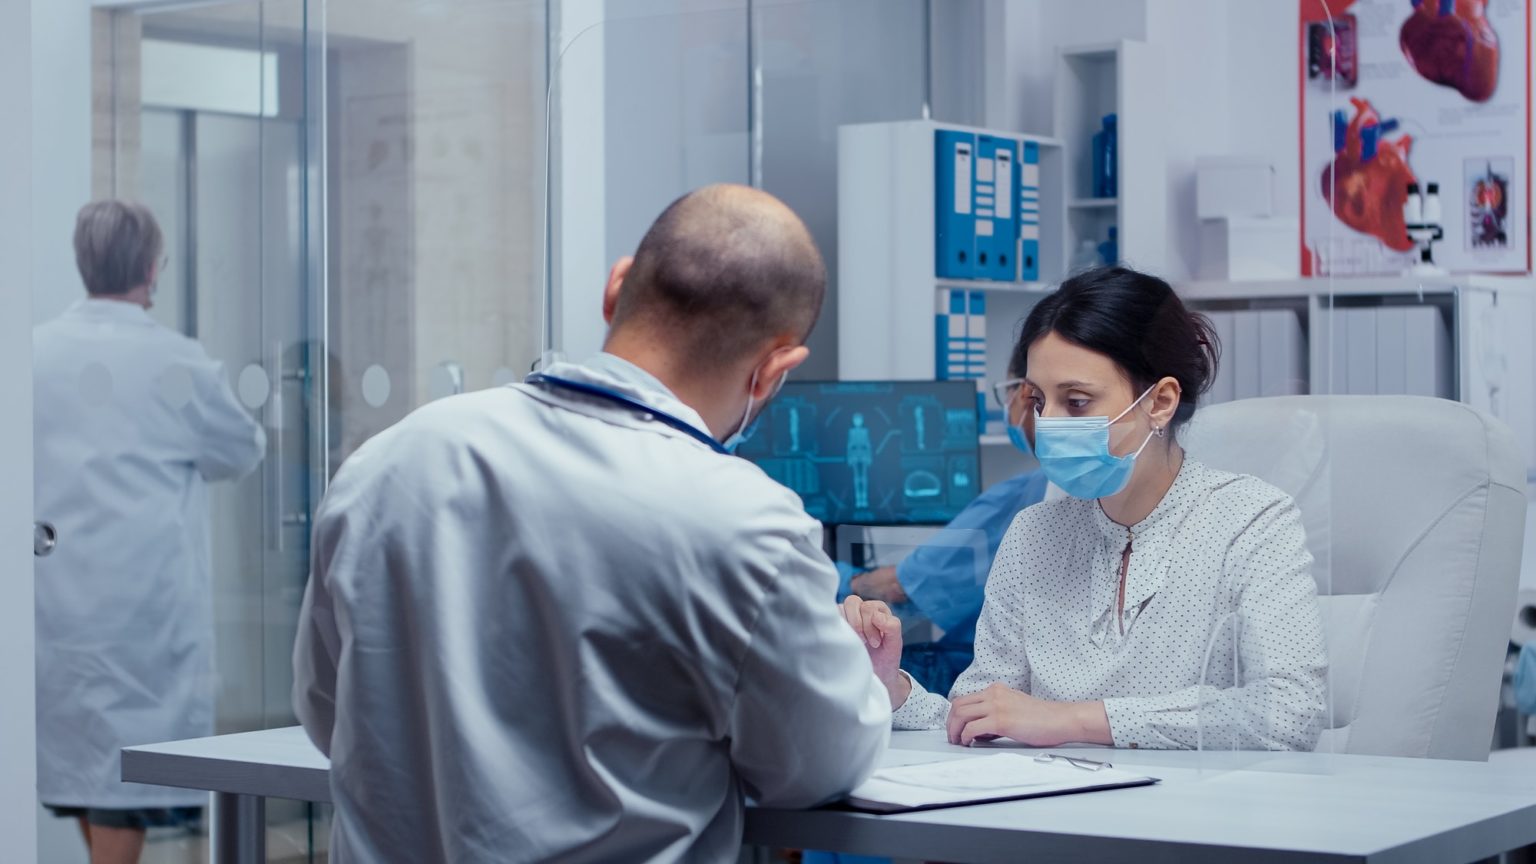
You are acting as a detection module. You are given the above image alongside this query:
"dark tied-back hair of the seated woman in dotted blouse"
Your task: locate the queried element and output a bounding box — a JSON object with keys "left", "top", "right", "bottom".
{"left": 1008, "top": 268, "right": 1221, "bottom": 427}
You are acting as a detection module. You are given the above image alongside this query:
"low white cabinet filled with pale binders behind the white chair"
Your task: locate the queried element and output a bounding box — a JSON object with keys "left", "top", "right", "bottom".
{"left": 1178, "top": 275, "right": 1536, "bottom": 466}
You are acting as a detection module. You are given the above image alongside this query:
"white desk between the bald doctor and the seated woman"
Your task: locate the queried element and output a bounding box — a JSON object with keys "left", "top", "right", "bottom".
{"left": 123, "top": 727, "right": 1536, "bottom": 864}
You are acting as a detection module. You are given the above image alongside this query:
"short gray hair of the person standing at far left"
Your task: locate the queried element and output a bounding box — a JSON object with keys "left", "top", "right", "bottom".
{"left": 75, "top": 201, "right": 164, "bottom": 295}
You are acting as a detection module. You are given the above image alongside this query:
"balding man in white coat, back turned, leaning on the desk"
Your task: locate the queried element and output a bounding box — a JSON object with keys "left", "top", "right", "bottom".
{"left": 295, "top": 186, "right": 899, "bottom": 864}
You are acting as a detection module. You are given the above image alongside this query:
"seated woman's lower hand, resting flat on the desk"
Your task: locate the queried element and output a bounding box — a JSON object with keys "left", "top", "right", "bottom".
{"left": 948, "top": 684, "right": 1114, "bottom": 747}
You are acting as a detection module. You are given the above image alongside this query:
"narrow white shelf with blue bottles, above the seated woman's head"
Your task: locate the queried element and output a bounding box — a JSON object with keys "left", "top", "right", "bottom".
{"left": 1055, "top": 40, "right": 1167, "bottom": 274}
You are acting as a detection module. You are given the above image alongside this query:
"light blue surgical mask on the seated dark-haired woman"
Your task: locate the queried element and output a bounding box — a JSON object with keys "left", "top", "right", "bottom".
{"left": 1008, "top": 387, "right": 1161, "bottom": 498}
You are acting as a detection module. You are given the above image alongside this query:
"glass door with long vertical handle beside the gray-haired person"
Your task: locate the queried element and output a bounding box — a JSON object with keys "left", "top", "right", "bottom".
{"left": 82, "top": 0, "right": 330, "bottom": 861}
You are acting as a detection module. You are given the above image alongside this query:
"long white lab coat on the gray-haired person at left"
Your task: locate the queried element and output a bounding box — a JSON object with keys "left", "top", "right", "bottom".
{"left": 32, "top": 300, "right": 266, "bottom": 809}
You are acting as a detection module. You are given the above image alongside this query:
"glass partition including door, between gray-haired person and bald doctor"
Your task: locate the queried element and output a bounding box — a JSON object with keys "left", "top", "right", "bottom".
{"left": 82, "top": 0, "right": 547, "bottom": 861}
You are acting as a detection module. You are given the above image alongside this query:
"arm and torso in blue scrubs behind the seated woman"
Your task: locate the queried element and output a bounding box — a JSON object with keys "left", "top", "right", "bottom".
{"left": 839, "top": 470, "right": 1046, "bottom": 693}
